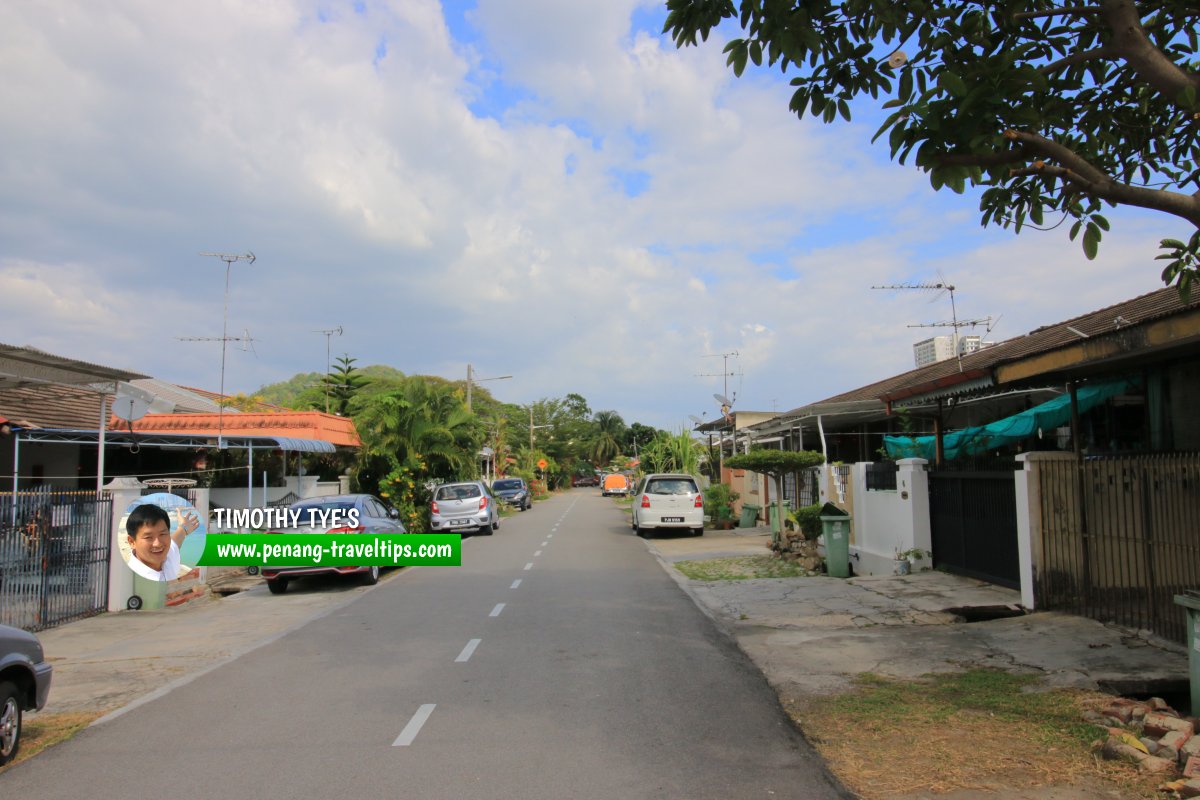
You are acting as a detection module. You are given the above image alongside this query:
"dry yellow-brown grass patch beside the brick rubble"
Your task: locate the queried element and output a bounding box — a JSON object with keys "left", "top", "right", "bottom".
{"left": 785, "top": 669, "right": 1163, "bottom": 800}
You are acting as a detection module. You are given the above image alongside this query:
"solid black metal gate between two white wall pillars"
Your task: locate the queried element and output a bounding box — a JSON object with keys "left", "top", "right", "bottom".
{"left": 929, "top": 464, "right": 1021, "bottom": 589}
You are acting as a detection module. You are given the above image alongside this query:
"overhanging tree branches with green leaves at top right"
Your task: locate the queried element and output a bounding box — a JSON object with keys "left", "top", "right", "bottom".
{"left": 664, "top": 0, "right": 1200, "bottom": 289}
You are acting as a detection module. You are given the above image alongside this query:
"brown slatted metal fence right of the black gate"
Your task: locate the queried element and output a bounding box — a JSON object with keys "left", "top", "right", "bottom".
{"left": 1037, "top": 453, "right": 1200, "bottom": 643}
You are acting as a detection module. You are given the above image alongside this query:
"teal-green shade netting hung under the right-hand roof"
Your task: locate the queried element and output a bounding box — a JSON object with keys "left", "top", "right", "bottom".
{"left": 883, "top": 378, "right": 1139, "bottom": 461}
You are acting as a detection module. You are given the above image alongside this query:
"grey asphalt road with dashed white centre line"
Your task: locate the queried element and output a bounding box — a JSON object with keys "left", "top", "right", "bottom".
{"left": 0, "top": 489, "right": 845, "bottom": 800}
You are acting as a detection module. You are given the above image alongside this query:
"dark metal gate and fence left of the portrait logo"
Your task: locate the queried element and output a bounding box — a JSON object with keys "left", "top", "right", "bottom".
{"left": 0, "top": 491, "right": 113, "bottom": 631}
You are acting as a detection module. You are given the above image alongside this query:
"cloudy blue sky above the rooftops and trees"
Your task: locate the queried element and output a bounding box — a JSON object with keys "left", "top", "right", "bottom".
{"left": 0, "top": 0, "right": 1183, "bottom": 427}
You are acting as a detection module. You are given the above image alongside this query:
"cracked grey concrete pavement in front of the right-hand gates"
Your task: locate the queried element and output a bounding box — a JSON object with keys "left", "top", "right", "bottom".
{"left": 648, "top": 528, "right": 1188, "bottom": 698}
